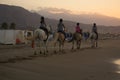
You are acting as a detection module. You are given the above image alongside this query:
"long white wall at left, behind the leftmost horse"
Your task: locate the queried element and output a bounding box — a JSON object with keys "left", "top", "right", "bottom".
{"left": 0, "top": 30, "right": 33, "bottom": 44}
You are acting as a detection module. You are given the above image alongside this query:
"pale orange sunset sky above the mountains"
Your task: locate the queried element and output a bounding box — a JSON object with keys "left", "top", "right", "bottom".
{"left": 0, "top": 0, "right": 120, "bottom": 18}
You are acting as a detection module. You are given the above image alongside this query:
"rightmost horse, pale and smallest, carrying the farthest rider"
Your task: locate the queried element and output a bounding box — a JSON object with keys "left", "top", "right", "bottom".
{"left": 90, "top": 32, "right": 98, "bottom": 48}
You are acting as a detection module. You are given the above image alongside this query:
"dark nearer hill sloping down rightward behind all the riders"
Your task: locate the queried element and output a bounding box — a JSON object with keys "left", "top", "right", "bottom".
{"left": 0, "top": 4, "right": 120, "bottom": 33}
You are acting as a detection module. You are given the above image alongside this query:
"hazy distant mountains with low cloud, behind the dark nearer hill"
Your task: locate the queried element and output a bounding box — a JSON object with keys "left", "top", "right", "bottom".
{"left": 36, "top": 8, "right": 120, "bottom": 26}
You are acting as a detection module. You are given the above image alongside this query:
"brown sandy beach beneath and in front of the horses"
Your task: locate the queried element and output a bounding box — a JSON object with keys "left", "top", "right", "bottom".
{"left": 0, "top": 40, "right": 120, "bottom": 80}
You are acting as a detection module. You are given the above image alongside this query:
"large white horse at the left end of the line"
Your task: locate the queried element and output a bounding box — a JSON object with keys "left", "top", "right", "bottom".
{"left": 32, "top": 26, "right": 50, "bottom": 55}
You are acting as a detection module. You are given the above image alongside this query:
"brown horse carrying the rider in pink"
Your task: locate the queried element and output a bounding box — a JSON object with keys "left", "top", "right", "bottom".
{"left": 70, "top": 32, "right": 82, "bottom": 49}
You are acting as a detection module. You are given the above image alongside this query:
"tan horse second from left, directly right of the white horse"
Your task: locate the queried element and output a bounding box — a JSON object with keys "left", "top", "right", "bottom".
{"left": 53, "top": 32, "right": 65, "bottom": 53}
